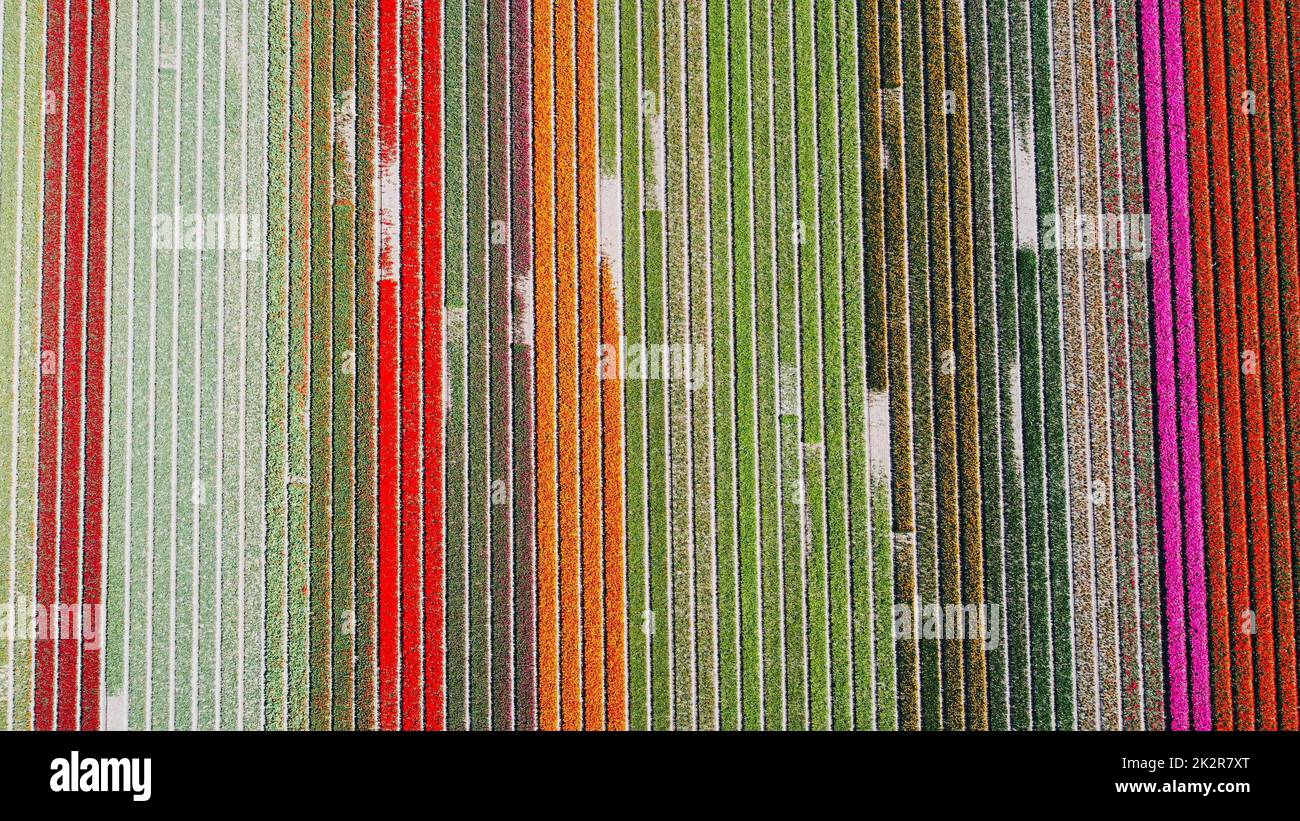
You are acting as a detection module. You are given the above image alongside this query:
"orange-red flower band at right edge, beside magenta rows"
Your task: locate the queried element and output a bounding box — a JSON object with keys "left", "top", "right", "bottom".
{"left": 1175, "top": 0, "right": 1300, "bottom": 730}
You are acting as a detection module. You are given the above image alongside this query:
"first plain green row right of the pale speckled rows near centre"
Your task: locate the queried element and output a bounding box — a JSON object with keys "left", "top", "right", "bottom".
{"left": 702, "top": 0, "right": 741, "bottom": 730}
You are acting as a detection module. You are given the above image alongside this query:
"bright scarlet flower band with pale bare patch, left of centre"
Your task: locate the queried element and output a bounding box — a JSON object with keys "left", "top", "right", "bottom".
{"left": 378, "top": 0, "right": 446, "bottom": 730}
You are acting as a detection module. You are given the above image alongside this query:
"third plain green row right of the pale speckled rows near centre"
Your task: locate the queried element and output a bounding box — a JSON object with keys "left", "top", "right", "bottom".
{"left": 750, "top": 0, "right": 787, "bottom": 729}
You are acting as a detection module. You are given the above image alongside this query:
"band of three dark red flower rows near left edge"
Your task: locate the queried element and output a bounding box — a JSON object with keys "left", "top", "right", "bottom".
{"left": 33, "top": 0, "right": 112, "bottom": 730}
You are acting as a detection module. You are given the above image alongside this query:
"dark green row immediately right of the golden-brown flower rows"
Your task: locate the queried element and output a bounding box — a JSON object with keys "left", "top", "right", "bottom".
{"left": 963, "top": 0, "right": 1014, "bottom": 730}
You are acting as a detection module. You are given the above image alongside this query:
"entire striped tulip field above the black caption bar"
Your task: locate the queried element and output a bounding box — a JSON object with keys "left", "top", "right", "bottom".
{"left": 0, "top": 0, "right": 1300, "bottom": 730}
